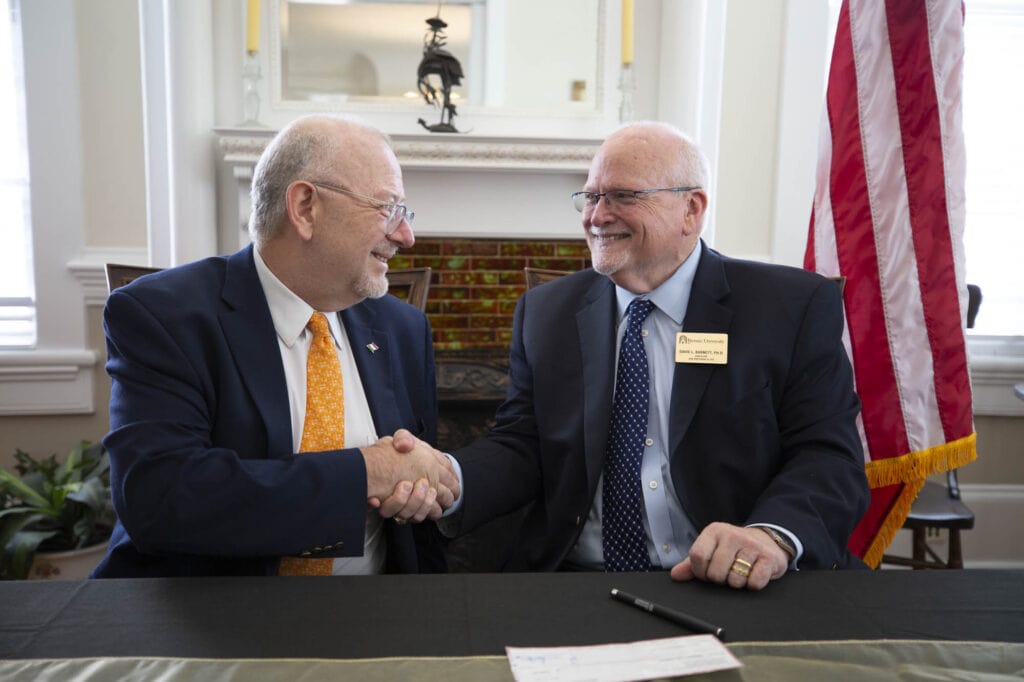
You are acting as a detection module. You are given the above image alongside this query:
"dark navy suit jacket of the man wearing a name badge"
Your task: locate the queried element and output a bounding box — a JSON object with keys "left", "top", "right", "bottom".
{"left": 455, "top": 241, "right": 868, "bottom": 570}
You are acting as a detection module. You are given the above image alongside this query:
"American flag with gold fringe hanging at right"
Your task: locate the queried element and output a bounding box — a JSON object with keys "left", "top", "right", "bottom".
{"left": 804, "top": 0, "right": 976, "bottom": 566}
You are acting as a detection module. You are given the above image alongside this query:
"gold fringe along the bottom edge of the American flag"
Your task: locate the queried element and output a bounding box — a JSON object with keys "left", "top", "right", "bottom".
{"left": 864, "top": 432, "right": 978, "bottom": 568}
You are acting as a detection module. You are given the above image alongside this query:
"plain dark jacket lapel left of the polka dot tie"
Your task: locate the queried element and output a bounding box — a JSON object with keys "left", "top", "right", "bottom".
{"left": 577, "top": 276, "right": 615, "bottom": 491}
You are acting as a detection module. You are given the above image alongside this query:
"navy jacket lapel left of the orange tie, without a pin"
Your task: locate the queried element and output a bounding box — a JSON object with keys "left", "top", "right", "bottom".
{"left": 220, "top": 246, "right": 294, "bottom": 457}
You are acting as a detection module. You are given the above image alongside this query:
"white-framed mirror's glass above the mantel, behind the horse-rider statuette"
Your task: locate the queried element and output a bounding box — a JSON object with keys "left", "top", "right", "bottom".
{"left": 260, "top": 0, "right": 620, "bottom": 137}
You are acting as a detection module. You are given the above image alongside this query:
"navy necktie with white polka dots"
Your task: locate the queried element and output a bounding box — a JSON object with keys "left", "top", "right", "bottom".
{"left": 601, "top": 298, "right": 654, "bottom": 571}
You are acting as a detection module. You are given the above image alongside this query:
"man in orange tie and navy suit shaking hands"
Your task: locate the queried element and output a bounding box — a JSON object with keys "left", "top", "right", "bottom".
{"left": 94, "top": 116, "right": 458, "bottom": 578}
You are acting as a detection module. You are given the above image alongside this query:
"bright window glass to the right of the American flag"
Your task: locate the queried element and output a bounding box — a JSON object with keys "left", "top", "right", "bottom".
{"left": 964, "top": 0, "right": 1024, "bottom": 336}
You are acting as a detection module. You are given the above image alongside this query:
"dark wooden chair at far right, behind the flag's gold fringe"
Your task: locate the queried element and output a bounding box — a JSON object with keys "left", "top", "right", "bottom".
{"left": 882, "top": 285, "right": 981, "bottom": 569}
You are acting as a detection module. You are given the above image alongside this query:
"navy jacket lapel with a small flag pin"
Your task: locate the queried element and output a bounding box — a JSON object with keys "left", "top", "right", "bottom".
{"left": 338, "top": 302, "right": 400, "bottom": 436}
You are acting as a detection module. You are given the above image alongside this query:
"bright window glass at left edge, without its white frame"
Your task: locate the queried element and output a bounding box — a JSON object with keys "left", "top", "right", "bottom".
{"left": 0, "top": 0, "right": 36, "bottom": 348}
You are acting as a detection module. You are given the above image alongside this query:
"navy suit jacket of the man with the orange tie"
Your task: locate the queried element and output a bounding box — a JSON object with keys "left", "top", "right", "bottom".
{"left": 93, "top": 247, "right": 444, "bottom": 578}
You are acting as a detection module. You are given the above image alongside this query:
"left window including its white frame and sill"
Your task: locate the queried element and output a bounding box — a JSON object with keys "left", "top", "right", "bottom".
{"left": 0, "top": 0, "right": 101, "bottom": 416}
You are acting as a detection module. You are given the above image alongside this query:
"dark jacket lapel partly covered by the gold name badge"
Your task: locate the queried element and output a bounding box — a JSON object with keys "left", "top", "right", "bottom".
{"left": 669, "top": 244, "right": 732, "bottom": 461}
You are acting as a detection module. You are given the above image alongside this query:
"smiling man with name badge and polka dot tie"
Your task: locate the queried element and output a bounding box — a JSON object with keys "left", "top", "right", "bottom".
{"left": 440, "top": 123, "right": 868, "bottom": 590}
